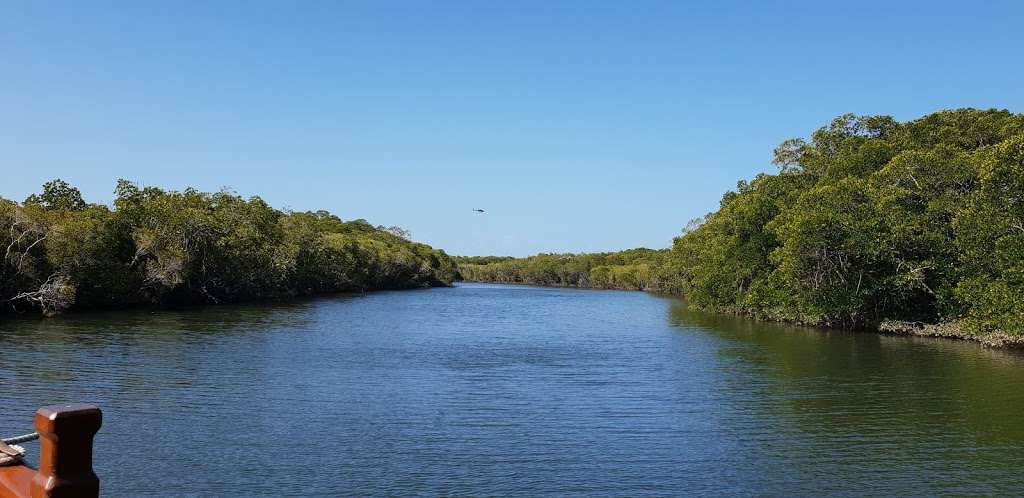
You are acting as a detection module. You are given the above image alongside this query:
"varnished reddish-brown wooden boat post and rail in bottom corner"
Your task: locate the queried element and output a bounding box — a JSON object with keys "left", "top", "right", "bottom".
{"left": 0, "top": 403, "right": 103, "bottom": 498}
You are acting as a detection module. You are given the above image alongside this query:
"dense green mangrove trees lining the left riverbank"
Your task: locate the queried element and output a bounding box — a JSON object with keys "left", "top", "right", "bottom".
{"left": 0, "top": 179, "right": 458, "bottom": 315}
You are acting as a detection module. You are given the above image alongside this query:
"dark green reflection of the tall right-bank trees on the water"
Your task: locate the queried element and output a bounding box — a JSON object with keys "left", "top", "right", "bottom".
{"left": 670, "top": 302, "right": 1024, "bottom": 495}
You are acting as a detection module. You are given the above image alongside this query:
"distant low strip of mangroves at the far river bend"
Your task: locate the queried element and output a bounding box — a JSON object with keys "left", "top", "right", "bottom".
{"left": 455, "top": 249, "right": 679, "bottom": 291}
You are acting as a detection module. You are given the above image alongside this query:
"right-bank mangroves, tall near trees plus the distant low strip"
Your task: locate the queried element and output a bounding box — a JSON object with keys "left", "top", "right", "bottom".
{"left": 455, "top": 109, "right": 1024, "bottom": 347}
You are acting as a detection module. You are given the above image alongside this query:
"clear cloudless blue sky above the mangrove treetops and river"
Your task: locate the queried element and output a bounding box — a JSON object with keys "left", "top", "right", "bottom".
{"left": 0, "top": 0, "right": 1024, "bottom": 256}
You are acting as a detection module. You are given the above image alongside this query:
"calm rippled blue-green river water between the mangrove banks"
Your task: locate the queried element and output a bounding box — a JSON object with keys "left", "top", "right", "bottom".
{"left": 0, "top": 284, "right": 1024, "bottom": 496}
